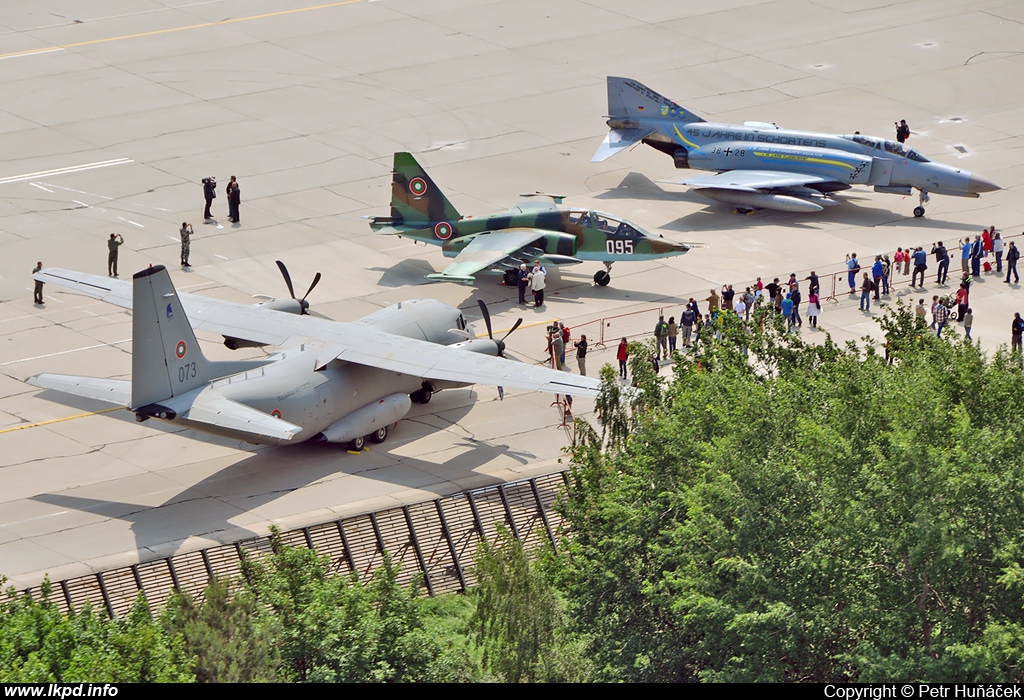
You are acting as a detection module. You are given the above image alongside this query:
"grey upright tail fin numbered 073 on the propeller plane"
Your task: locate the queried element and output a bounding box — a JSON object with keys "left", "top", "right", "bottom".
{"left": 130, "top": 265, "right": 266, "bottom": 410}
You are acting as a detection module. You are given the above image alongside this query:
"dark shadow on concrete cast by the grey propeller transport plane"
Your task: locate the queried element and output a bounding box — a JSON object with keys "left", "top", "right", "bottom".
{"left": 30, "top": 389, "right": 536, "bottom": 562}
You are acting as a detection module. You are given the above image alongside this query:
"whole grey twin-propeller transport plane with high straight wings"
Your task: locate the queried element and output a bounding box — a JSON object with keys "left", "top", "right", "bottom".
{"left": 29, "top": 265, "right": 599, "bottom": 449}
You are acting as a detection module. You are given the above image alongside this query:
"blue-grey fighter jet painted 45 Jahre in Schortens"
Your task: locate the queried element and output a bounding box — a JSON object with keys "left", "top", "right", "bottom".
{"left": 591, "top": 76, "right": 999, "bottom": 216}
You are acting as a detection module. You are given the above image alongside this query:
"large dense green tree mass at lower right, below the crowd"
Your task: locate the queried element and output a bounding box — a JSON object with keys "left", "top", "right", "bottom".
{"left": 558, "top": 307, "right": 1024, "bottom": 682}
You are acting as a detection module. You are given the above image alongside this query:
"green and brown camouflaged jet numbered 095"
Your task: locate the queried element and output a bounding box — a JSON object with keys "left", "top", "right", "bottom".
{"left": 370, "top": 154, "right": 695, "bottom": 287}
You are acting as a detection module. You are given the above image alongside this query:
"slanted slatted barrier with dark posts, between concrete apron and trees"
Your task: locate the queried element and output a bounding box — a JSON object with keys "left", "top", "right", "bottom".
{"left": 25, "top": 472, "right": 565, "bottom": 615}
